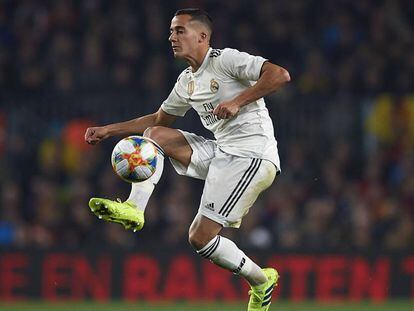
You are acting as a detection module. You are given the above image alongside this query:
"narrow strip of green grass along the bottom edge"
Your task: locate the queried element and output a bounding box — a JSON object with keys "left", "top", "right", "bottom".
{"left": 0, "top": 300, "right": 414, "bottom": 311}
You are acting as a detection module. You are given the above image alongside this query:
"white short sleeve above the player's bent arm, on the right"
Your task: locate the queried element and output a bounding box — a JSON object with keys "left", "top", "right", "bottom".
{"left": 221, "top": 49, "right": 267, "bottom": 81}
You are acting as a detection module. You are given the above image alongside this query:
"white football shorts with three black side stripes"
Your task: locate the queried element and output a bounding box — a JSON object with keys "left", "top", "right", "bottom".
{"left": 170, "top": 130, "right": 277, "bottom": 228}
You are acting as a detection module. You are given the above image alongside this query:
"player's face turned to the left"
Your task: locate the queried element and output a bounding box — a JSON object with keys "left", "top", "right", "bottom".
{"left": 168, "top": 14, "right": 200, "bottom": 58}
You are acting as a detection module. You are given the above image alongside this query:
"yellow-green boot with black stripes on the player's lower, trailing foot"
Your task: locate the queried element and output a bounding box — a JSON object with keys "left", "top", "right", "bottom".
{"left": 247, "top": 268, "right": 279, "bottom": 311}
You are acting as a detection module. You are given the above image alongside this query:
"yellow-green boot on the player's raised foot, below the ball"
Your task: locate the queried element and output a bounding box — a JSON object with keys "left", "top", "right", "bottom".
{"left": 89, "top": 198, "right": 145, "bottom": 232}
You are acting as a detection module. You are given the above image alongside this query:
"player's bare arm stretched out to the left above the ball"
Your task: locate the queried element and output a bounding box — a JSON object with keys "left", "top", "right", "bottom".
{"left": 85, "top": 108, "right": 177, "bottom": 145}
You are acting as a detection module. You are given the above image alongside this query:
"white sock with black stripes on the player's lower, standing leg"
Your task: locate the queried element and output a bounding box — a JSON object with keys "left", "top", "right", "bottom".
{"left": 197, "top": 235, "right": 267, "bottom": 286}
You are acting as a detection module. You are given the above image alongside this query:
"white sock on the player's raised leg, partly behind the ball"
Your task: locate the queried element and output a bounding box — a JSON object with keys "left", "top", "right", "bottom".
{"left": 127, "top": 143, "right": 164, "bottom": 212}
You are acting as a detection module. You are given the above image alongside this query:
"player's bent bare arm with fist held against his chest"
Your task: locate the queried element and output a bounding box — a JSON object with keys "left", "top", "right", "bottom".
{"left": 213, "top": 62, "right": 290, "bottom": 119}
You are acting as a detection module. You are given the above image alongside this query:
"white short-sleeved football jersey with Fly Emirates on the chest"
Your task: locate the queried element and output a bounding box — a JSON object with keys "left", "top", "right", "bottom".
{"left": 161, "top": 48, "right": 280, "bottom": 170}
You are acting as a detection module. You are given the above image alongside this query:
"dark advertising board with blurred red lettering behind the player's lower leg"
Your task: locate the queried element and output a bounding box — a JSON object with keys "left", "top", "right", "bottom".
{"left": 0, "top": 251, "right": 414, "bottom": 301}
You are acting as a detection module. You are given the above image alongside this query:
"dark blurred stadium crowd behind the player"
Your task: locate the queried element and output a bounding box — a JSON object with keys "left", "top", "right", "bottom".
{"left": 0, "top": 0, "right": 414, "bottom": 251}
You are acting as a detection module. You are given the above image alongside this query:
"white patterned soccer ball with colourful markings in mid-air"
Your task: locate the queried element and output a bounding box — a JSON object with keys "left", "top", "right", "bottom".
{"left": 111, "top": 136, "right": 157, "bottom": 183}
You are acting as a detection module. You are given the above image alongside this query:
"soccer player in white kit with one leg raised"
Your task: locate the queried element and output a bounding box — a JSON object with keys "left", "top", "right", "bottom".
{"left": 85, "top": 9, "right": 290, "bottom": 311}
